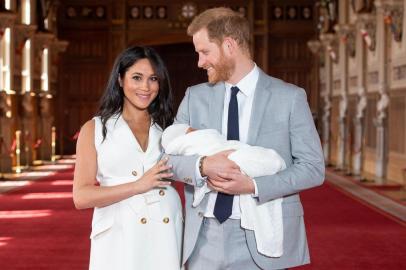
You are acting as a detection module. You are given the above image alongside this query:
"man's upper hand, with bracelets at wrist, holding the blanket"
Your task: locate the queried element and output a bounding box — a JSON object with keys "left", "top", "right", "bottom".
{"left": 203, "top": 150, "right": 240, "bottom": 181}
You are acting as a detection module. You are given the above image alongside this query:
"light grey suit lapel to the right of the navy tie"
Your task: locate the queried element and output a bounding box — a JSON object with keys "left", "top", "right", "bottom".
{"left": 247, "top": 70, "right": 272, "bottom": 145}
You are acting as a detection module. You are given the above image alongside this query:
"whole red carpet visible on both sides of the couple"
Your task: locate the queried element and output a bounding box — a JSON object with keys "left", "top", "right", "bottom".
{"left": 0, "top": 172, "right": 406, "bottom": 270}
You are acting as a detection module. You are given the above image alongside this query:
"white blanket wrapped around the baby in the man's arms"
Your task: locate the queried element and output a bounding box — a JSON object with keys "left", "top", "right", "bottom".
{"left": 162, "top": 124, "right": 286, "bottom": 257}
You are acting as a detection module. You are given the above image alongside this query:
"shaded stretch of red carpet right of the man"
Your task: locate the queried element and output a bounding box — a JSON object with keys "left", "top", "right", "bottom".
{"left": 295, "top": 182, "right": 406, "bottom": 270}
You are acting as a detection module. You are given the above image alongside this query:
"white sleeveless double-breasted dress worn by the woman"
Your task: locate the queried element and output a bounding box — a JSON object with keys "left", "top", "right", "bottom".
{"left": 89, "top": 116, "right": 183, "bottom": 270}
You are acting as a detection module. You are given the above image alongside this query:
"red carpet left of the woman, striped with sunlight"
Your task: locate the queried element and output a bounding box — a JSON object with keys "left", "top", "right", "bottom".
{"left": 0, "top": 172, "right": 92, "bottom": 270}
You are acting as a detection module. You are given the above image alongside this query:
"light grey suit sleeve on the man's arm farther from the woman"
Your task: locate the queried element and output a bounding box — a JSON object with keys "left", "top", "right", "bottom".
{"left": 255, "top": 89, "right": 325, "bottom": 203}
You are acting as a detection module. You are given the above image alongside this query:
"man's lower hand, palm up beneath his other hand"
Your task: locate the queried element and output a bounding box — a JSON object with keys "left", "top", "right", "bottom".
{"left": 207, "top": 172, "right": 255, "bottom": 195}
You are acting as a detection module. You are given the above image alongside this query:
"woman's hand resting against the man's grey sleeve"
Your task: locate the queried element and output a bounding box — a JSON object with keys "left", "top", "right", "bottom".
{"left": 135, "top": 159, "right": 173, "bottom": 193}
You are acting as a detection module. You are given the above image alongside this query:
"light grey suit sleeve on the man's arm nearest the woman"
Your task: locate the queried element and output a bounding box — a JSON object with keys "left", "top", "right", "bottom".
{"left": 166, "top": 88, "right": 204, "bottom": 186}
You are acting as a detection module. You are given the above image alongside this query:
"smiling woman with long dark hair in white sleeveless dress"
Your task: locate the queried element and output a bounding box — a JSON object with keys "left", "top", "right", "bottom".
{"left": 73, "top": 47, "right": 182, "bottom": 270}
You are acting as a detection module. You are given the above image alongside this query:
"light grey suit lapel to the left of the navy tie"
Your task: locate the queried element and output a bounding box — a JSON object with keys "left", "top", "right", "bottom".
{"left": 207, "top": 83, "right": 226, "bottom": 133}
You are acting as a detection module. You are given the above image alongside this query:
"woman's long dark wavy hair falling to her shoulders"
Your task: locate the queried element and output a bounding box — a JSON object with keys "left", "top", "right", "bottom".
{"left": 97, "top": 46, "right": 174, "bottom": 141}
